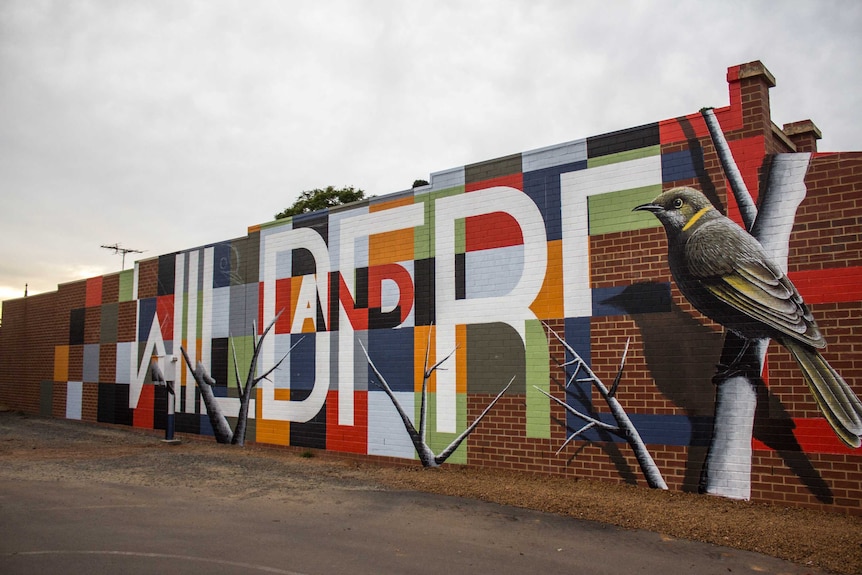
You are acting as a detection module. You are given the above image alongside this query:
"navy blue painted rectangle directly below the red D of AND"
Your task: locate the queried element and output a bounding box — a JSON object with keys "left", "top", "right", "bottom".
{"left": 368, "top": 328, "right": 414, "bottom": 391}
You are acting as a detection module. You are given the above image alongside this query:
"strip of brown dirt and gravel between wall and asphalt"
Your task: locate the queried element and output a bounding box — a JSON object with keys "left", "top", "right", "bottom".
{"left": 0, "top": 411, "right": 862, "bottom": 574}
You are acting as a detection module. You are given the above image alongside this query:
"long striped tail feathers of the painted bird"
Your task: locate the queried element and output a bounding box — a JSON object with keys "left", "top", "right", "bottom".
{"left": 781, "top": 339, "right": 862, "bottom": 448}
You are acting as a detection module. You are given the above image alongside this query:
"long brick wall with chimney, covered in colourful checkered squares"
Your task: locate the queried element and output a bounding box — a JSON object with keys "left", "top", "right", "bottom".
{"left": 5, "top": 62, "right": 862, "bottom": 514}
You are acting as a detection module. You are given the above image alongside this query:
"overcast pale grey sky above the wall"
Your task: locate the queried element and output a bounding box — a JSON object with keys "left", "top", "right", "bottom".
{"left": 0, "top": 0, "right": 862, "bottom": 310}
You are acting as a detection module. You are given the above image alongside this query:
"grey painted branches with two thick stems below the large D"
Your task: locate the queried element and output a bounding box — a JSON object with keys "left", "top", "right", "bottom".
{"left": 180, "top": 310, "right": 302, "bottom": 445}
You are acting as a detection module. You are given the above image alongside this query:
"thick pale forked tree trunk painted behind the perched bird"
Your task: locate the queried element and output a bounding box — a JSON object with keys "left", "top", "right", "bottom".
{"left": 700, "top": 109, "right": 811, "bottom": 499}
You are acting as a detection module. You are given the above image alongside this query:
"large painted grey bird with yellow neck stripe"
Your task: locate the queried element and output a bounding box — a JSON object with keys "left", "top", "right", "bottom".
{"left": 634, "top": 187, "right": 862, "bottom": 448}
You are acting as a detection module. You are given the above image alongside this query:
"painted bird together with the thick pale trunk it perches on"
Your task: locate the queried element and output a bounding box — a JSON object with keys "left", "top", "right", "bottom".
{"left": 634, "top": 109, "right": 862, "bottom": 499}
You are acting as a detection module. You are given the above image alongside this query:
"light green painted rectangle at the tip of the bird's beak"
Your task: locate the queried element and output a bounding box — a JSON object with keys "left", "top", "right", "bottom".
{"left": 587, "top": 184, "right": 661, "bottom": 236}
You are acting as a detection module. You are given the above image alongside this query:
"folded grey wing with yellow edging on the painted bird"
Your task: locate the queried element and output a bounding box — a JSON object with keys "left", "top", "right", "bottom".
{"left": 686, "top": 222, "right": 826, "bottom": 348}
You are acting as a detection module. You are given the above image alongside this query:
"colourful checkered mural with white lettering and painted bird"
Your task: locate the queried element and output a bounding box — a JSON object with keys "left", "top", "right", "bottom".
{"left": 44, "top": 64, "right": 862, "bottom": 512}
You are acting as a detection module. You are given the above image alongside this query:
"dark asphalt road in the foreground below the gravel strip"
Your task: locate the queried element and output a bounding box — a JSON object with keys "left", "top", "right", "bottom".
{"left": 0, "top": 476, "right": 828, "bottom": 575}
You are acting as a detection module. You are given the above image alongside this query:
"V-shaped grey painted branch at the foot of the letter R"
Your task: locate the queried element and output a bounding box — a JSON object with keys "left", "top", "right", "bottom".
{"left": 359, "top": 330, "right": 515, "bottom": 467}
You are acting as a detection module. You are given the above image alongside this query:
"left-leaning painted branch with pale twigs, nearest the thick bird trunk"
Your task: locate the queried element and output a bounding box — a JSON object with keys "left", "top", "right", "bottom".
{"left": 536, "top": 324, "right": 667, "bottom": 489}
